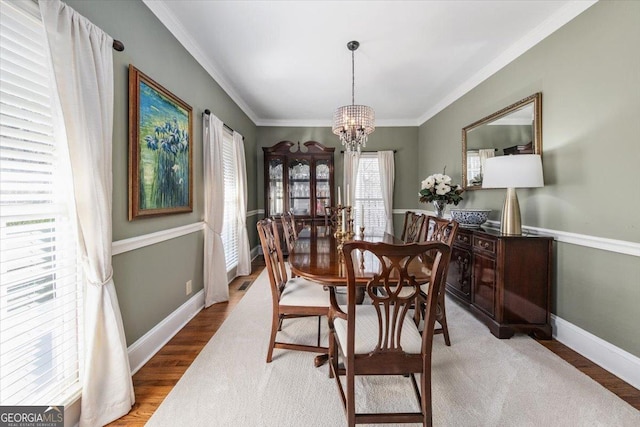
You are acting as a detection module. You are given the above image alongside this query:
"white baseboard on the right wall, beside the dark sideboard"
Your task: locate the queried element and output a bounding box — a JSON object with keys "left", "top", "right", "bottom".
{"left": 551, "top": 314, "right": 640, "bottom": 390}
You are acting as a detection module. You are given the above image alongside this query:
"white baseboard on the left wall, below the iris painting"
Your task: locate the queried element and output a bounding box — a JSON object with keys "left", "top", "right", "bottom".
{"left": 127, "top": 289, "right": 204, "bottom": 375}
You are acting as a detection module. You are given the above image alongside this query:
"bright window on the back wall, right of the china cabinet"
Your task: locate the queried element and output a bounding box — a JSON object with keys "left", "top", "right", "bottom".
{"left": 354, "top": 153, "right": 385, "bottom": 234}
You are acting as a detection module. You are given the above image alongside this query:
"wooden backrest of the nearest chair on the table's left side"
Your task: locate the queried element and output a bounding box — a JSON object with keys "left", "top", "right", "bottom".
{"left": 256, "top": 218, "right": 288, "bottom": 302}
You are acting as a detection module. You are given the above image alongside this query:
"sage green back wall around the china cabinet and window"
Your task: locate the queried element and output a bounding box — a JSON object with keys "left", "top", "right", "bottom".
{"left": 256, "top": 126, "right": 420, "bottom": 234}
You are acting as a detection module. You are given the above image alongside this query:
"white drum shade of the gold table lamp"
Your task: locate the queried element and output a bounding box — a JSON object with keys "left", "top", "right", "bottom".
{"left": 482, "top": 154, "right": 544, "bottom": 188}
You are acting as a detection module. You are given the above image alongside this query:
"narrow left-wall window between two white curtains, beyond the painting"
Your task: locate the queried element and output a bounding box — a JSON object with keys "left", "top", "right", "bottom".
{"left": 222, "top": 131, "right": 238, "bottom": 273}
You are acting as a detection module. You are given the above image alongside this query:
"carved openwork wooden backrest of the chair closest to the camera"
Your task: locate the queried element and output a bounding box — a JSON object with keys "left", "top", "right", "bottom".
{"left": 343, "top": 241, "right": 451, "bottom": 359}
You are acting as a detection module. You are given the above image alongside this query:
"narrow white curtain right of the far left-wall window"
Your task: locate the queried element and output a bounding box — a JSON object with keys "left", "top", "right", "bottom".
{"left": 233, "top": 131, "right": 251, "bottom": 276}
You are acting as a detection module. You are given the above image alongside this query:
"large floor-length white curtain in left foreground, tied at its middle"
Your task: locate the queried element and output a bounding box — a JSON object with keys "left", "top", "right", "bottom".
{"left": 40, "top": 0, "right": 135, "bottom": 426}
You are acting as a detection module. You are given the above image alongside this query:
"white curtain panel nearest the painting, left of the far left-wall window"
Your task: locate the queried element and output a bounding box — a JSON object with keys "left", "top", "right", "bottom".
{"left": 202, "top": 114, "right": 229, "bottom": 307}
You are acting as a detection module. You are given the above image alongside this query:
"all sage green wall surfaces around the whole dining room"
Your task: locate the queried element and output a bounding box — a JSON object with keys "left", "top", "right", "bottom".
{"left": 67, "top": 0, "right": 640, "bottom": 362}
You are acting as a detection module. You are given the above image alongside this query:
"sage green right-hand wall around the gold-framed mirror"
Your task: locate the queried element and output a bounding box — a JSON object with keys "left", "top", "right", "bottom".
{"left": 418, "top": 1, "right": 640, "bottom": 356}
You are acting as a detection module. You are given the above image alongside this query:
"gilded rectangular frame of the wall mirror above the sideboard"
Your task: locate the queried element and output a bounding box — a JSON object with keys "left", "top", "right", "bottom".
{"left": 462, "top": 92, "right": 542, "bottom": 191}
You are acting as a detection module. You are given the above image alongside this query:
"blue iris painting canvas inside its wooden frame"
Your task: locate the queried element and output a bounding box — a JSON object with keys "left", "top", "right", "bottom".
{"left": 138, "top": 82, "right": 190, "bottom": 210}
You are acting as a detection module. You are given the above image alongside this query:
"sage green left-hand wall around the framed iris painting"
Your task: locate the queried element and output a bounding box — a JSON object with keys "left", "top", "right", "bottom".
{"left": 65, "top": 0, "right": 257, "bottom": 345}
